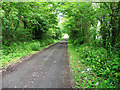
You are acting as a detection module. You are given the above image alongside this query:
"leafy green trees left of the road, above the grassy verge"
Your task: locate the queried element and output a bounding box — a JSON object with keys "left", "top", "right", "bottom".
{"left": 1, "top": 2, "right": 60, "bottom": 46}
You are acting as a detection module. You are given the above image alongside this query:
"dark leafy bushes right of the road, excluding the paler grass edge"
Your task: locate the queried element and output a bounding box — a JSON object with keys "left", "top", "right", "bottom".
{"left": 68, "top": 44, "right": 120, "bottom": 88}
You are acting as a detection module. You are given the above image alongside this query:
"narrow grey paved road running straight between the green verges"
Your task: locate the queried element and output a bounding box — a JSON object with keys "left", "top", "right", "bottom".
{"left": 2, "top": 39, "right": 70, "bottom": 88}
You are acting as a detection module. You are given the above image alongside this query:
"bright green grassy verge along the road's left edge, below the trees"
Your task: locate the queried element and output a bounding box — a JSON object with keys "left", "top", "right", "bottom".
{"left": 0, "top": 39, "right": 59, "bottom": 68}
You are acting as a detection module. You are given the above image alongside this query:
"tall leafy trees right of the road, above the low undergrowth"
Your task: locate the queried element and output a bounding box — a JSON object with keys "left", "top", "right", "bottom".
{"left": 62, "top": 2, "right": 120, "bottom": 48}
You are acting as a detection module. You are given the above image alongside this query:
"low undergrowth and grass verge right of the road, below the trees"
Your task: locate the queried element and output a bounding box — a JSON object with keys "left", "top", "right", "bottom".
{"left": 68, "top": 43, "right": 120, "bottom": 88}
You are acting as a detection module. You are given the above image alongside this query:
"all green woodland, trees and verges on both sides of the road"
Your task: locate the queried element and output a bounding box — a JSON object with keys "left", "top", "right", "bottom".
{"left": 1, "top": 2, "right": 120, "bottom": 88}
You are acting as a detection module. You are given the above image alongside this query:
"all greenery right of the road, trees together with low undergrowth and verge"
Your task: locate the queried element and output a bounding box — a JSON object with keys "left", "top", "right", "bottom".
{"left": 62, "top": 2, "right": 120, "bottom": 88}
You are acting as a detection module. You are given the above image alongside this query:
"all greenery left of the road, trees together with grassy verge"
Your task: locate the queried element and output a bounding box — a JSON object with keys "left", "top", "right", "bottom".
{"left": 0, "top": 2, "right": 61, "bottom": 66}
